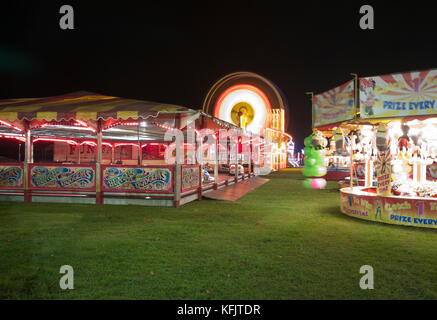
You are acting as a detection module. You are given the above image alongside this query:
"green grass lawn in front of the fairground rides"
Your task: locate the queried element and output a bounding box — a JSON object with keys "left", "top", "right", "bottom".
{"left": 0, "top": 170, "right": 437, "bottom": 299}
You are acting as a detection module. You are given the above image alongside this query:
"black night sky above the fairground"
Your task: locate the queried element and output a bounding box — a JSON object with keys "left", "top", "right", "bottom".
{"left": 0, "top": 1, "right": 437, "bottom": 150}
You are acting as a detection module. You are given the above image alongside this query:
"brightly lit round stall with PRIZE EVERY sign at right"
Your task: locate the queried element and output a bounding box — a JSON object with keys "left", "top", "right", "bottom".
{"left": 312, "top": 70, "right": 437, "bottom": 228}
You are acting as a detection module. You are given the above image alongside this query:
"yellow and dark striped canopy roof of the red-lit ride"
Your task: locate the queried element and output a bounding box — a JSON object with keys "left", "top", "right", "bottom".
{"left": 0, "top": 91, "right": 197, "bottom": 121}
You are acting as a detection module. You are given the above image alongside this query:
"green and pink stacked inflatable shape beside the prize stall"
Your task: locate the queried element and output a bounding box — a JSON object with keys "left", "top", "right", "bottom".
{"left": 303, "top": 135, "right": 327, "bottom": 189}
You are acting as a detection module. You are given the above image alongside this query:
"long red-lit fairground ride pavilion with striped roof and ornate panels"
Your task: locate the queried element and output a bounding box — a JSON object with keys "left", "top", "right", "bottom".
{"left": 0, "top": 92, "right": 263, "bottom": 206}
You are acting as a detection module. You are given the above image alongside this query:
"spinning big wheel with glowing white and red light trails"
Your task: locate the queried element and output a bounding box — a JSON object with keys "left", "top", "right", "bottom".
{"left": 203, "top": 72, "right": 292, "bottom": 170}
